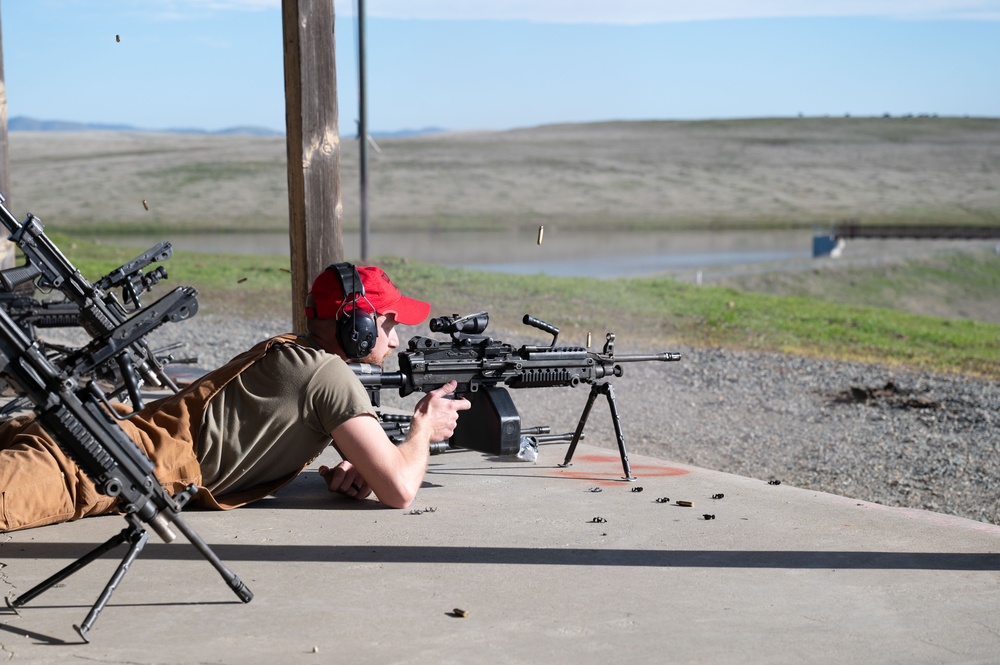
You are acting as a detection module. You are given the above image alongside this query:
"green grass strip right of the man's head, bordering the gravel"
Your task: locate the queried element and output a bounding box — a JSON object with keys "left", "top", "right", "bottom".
{"left": 376, "top": 262, "right": 1000, "bottom": 377}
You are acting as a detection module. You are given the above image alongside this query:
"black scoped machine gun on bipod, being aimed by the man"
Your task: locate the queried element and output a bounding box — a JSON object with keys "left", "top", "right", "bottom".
{"left": 351, "top": 312, "right": 681, "bottom": 480}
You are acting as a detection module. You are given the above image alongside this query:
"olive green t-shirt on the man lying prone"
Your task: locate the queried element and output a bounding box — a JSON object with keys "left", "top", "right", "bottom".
{"left": 198, "top": 344, "right": 377, "bottom": 495}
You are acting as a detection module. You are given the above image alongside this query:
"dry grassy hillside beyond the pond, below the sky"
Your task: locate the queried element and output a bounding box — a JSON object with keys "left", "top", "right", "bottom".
{"left": 4, "top": 118, "right": 1000, "bottom": 231}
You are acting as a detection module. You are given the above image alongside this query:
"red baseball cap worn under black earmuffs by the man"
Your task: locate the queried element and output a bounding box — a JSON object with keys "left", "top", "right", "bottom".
{"left": 306, "top": 266, "right": 431, "bottom": 326}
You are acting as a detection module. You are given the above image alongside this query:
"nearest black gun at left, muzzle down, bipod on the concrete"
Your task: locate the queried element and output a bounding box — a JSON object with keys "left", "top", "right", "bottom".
{"left": 0, "top": 309, "right": 253, "bottom": 641}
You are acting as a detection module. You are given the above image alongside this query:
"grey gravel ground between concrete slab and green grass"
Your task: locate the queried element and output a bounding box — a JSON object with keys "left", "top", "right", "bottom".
{"left": 135, "top": 315, "right": 1000, "bottom": 524}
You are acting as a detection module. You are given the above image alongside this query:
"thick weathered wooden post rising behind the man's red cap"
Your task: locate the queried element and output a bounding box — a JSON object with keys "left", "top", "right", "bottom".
{"left": 281, "top": 0, "right": 344, "bottom": 331}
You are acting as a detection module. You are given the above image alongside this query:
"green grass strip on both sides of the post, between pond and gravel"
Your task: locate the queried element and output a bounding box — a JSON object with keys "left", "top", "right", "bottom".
{"left": 54, "top": 237, "right": 1000, "bottom": 378}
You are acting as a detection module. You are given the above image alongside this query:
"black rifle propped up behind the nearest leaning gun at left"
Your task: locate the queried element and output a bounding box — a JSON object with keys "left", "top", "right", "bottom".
{"left": 0, "top": 194, "right": 198, "bottom": 410}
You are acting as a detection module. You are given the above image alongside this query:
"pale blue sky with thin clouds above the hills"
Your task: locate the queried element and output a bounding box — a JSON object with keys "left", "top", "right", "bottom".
{"left": 0, "top": 0, "right": 1000, "bottom": 135}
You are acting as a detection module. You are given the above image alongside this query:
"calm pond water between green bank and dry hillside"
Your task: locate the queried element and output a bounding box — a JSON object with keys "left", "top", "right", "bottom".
{"left": 101, "top": 229, "right": 995, "bottom": 281}
